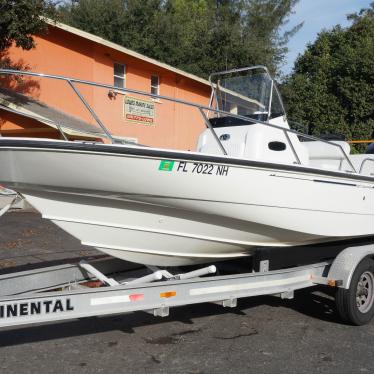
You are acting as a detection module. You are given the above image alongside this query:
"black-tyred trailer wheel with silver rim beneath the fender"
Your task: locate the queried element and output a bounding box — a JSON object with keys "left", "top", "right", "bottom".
{"left": 335, "top": 258, "right": 374, "bottom": 326}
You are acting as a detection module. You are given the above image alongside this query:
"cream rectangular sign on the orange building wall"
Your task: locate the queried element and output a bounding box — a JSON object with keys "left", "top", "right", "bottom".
{"left": 124, "top": 96, "right": 155, "bottom": 125}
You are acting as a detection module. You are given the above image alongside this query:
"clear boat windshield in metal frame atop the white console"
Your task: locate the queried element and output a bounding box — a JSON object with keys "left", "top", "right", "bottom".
{"left": 210, "top": 67, "right": 285, "bottom": 125}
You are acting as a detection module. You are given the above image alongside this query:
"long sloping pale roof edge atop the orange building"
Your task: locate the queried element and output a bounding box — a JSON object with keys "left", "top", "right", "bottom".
{"left": 48, "top": 20, "right": 210, "bottom": 87}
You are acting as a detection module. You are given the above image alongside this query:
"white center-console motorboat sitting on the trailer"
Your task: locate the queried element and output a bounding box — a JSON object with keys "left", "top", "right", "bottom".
{"left": 0, "top": 67, "right": 374, "bottom": 266}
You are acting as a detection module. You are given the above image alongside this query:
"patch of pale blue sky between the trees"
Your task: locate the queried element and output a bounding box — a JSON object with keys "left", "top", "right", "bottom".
{"left": 282, "top": 0, "right": 373, "bottom": 74}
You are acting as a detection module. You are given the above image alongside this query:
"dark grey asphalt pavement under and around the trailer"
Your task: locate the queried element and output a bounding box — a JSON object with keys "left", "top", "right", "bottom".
{"left": 0, "top": 212, "right": 374, "bottom": 374}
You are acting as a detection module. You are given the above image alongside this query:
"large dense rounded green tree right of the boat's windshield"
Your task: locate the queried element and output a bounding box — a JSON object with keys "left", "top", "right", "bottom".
{"left": 282, "top": 3, "right": 374, "bottom": 145}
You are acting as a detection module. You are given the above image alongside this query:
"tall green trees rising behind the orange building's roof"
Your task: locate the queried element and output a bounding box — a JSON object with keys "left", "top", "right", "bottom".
{"left": 59, "top": 0, "right": 301, "bottom": 77}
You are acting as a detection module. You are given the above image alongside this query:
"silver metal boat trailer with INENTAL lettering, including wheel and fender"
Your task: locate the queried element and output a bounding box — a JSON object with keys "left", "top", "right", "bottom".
{"left": 0, "top": 244, "right": 374, "bottom": 327}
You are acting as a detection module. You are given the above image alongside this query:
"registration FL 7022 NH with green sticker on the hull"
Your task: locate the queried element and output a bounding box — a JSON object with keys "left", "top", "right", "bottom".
{"left": 158, "top": 160, "right": 230, "bottom": 177}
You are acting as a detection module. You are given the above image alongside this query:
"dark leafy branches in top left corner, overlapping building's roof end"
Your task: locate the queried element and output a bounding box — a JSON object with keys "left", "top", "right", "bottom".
{"left": 0, "top": 0, "right": 55, "bottom": 52}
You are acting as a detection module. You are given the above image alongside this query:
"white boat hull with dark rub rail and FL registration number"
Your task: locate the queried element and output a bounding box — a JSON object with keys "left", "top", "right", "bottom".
{"left": 0, "top": 141, "right": 374, "bottom": 266}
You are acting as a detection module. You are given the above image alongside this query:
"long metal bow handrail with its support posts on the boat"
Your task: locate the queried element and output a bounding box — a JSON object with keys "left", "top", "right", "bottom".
{"left": 0, "top": 70, "right": 357, "bottom": 173}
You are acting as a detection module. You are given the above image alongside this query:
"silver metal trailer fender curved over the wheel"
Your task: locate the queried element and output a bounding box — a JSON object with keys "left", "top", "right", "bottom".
{"left": 328, "top": 244, "right": 374, "bottom": 289}
